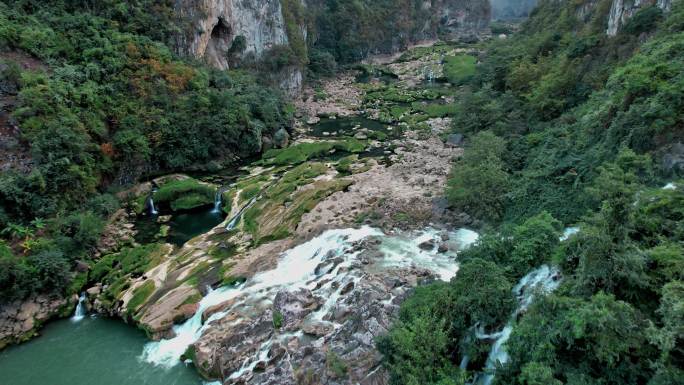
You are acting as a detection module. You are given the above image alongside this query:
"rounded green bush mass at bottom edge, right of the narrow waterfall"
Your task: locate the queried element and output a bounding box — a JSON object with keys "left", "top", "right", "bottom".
{"left": 502, "top": 293, "right": 654, "bottom": 385}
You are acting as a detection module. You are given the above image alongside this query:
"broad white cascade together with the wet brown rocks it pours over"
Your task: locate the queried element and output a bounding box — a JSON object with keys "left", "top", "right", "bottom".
{"left": 143, "top": 227, "right": 477, "bottom": 384}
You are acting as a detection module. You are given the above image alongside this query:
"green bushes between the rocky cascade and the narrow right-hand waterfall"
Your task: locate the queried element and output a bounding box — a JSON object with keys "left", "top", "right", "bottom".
{"left": 377, "top": 259, "right": 515, "bottom": 385}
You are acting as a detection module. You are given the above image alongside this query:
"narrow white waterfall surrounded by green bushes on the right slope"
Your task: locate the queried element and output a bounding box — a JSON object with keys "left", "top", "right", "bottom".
{"left": 474, "top": 265, "right": 560, "bottom": 385}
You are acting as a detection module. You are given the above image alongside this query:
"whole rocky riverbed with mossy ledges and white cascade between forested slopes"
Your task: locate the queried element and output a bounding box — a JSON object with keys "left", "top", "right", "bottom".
{"left": 3, "top": 40, "right": 477, "bottom": 384}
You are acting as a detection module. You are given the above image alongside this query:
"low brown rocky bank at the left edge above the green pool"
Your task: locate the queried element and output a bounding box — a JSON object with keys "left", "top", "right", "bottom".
{"left": 0, "top": 295, "right": 68, "bottom": 349}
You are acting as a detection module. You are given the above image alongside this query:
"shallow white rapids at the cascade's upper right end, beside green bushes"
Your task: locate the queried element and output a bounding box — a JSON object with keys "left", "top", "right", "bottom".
{"left": 380, "top": 228, "right": 479, "bottom": 281}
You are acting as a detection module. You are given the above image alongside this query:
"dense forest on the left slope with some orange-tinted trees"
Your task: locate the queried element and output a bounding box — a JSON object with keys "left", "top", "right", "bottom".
{"left": 0, "top": 0, "right": 292, "bottom": 302}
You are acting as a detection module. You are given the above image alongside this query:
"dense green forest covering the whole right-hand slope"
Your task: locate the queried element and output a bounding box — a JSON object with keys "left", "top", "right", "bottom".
{"left": 378, "top": 0, "right": 684, "bottom": 385}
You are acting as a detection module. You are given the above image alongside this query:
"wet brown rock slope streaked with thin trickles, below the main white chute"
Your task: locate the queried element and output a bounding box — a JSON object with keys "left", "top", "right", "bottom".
{"left": 187, "top": 235, "right": 448, "bottom": 384}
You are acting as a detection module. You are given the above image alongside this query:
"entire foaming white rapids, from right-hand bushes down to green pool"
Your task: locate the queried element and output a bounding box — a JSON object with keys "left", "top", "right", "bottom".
{"left": 142, "top": 226, "right": 478, "bottom": 368}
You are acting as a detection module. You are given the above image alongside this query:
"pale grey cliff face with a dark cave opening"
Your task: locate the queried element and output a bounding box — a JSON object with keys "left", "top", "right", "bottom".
{"left": 176, "top": 0, "right": 288, "bottom": 69}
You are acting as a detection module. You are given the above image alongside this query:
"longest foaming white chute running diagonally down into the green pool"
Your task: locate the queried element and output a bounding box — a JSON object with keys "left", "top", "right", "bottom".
{"left": 142, "top": 227, "right": 382, "bottom": 367}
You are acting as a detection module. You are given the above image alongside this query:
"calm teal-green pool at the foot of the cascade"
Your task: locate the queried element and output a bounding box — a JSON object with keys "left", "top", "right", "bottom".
{"left": 0, "top": 316, "right": 203, "bottom": 385}
